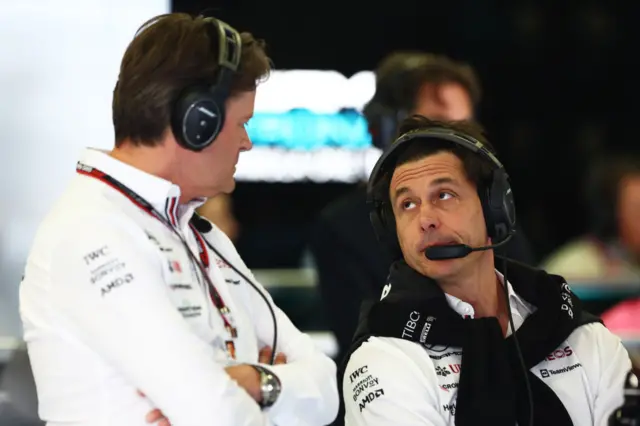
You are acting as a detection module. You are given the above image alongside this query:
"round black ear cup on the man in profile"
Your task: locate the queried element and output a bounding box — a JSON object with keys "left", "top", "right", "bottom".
{"left": 171, "top": 88, "right": 225, "bottom": 151}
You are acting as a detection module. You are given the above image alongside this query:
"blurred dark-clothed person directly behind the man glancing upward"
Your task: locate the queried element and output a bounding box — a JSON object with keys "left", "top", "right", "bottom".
{"left": 309, "top": 51, "right": 535, "bottom": 368}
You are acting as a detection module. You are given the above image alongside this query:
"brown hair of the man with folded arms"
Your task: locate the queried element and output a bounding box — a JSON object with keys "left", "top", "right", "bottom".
{"left": 112, "top": 13, "right": 271, "bottom": 146}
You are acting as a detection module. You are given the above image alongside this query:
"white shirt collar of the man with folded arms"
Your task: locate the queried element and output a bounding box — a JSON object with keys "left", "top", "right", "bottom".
{"left": 80, "top": 148, "right": 206, "bottom": 228}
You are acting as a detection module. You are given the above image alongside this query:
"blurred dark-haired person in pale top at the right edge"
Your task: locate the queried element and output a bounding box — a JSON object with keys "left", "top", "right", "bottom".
{"left": 542, "top": 155, "right": 640, "bottom": 284}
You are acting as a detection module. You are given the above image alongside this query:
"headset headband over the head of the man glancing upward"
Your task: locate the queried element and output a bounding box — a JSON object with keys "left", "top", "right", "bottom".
{"left": 367, "top": 127, "right": 504, "bottom": 202}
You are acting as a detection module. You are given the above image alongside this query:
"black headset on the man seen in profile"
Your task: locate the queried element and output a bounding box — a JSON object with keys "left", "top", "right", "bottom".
{"left": 171, "top": 17, "right": 242, "bottom": 151}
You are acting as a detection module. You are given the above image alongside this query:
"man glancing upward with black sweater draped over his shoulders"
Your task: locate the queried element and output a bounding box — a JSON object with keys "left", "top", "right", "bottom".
{"left": 342, "top": 116, "right": 631, "bottom": 426}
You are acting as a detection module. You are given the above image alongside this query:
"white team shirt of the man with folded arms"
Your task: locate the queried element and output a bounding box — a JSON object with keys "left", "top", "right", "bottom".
{"left": 20, "top": 149, "right": 338, "bottom": 426}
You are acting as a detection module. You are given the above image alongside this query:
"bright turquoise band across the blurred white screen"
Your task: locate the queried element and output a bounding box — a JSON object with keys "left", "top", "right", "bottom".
{"left": 247, "top": 109, "right": 371, "bottom": 151}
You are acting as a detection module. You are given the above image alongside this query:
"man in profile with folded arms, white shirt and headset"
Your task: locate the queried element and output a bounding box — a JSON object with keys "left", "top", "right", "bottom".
{"left": 20, "top": 14, "right": 338, "bottom": 426}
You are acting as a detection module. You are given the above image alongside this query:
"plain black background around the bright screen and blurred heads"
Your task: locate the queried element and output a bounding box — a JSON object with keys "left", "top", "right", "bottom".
{"left": 173, "top": 0, "right": 640, "bottom": 268}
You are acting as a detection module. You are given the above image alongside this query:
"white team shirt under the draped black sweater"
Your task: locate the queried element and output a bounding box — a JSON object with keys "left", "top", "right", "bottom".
{"left": 342, "top": 271, "right": 631, "bottom": 426}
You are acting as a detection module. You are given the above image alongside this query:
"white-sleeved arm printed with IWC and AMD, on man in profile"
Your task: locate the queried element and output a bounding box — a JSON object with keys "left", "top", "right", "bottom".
{"left": 50, "top": 218, "right": 270, "bottom": 426}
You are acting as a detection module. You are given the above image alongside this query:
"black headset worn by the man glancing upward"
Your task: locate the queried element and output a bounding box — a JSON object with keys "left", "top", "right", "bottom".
{"left": 367, "top": 127, "right": 516, "bottom": 258}
